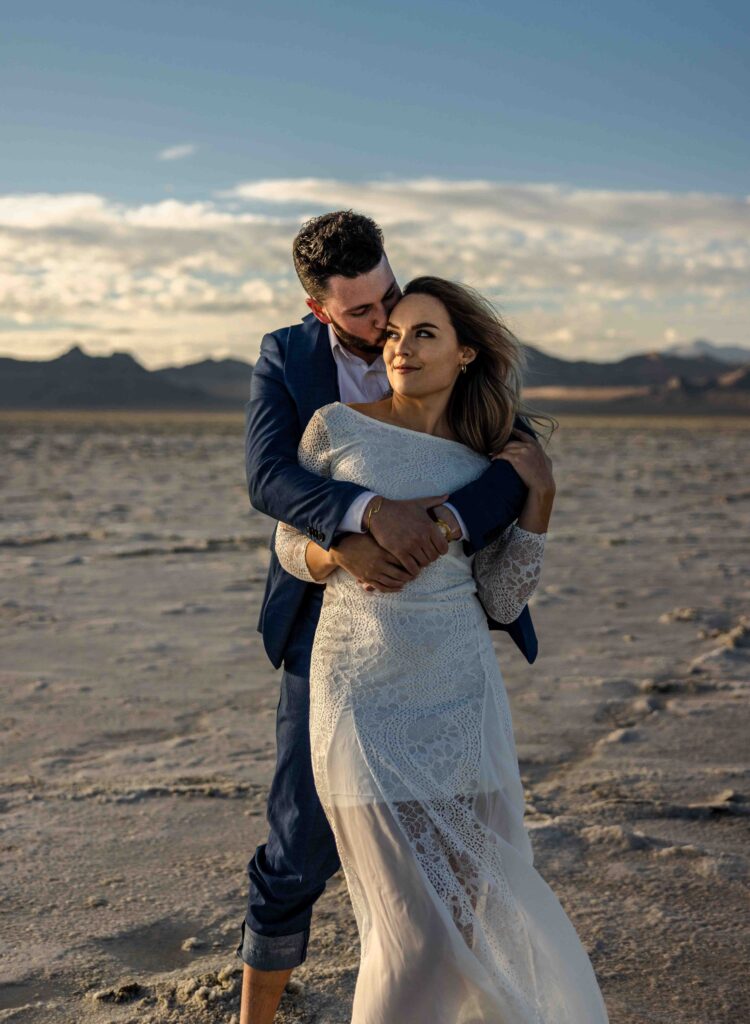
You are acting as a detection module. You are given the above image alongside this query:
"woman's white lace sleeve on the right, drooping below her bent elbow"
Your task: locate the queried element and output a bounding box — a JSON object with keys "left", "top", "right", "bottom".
{"left": 473, "top": 523, "right": 547, "bottom": 623}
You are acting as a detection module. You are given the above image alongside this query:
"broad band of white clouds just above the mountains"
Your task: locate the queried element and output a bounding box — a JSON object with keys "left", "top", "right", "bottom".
{"left": 0, "top": 178, "right": 750, "bottom": 366}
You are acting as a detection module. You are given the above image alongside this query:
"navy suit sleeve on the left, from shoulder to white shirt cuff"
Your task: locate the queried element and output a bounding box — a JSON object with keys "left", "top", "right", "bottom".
{"left": 245, "top": 334, "right": 366, "bottom": 550}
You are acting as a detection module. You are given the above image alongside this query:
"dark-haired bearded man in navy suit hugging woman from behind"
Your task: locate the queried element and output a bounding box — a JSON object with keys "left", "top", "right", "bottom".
{"left": 237, "top": 211, "right": 537, "bottom": 1024}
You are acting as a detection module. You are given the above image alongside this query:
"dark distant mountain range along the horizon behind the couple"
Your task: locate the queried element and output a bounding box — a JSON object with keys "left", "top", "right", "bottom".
{"left": 0, "top": 339, "right": 750, "bottom": 411}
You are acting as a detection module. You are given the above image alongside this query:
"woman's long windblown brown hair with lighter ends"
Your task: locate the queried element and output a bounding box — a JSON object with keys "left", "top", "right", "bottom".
{"left": 404, "top": 276, "right": 559, "bottom": 455}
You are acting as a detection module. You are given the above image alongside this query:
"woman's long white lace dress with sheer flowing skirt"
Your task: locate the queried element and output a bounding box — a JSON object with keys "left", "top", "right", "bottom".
{"left": 276, "top": 402, "right": 608, "bottom": 1024}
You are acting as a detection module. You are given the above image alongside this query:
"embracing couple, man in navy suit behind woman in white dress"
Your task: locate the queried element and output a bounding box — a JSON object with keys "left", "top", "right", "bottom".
{"left": 237, "top": 211, "right": 608, "bottom": 1024}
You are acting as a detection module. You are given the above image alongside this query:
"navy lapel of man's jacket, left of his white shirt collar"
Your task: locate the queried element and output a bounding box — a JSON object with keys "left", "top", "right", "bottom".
{"left": 286, "top": 313, "right": 339, "bottom": 427}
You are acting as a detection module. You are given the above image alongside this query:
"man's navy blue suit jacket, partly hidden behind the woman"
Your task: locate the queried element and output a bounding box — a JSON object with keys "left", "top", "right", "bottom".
{"left": 245, "top": 313, "right": 537, "bottom": 668}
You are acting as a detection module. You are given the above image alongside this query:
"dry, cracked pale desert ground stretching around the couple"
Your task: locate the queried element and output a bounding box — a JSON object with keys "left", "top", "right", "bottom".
{"left": 0, "top": 414, "right": 750, "bottom": 1024}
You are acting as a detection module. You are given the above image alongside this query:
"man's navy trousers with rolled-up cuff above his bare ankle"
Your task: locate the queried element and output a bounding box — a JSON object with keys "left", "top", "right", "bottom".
{"left": 237, "top": 588, "right": 340, "bottom": 971}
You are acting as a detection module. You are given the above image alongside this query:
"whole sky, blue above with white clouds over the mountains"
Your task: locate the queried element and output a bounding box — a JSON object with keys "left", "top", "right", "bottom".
{"left": 0, "top": 0, "right": 750, "bottom": 369}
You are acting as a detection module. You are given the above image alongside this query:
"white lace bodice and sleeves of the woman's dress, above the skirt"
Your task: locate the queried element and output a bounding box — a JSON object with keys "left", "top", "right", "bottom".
{"left": 275, "top": 402, "right": 546, "bottom": 623}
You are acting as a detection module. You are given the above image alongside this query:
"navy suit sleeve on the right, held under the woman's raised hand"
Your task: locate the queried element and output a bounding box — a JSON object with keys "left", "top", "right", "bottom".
{"left": 449, "top": 416, "right": 536, "bottom": 554}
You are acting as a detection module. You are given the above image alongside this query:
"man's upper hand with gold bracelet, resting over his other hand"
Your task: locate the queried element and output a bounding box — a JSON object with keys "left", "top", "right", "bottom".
{"left": 363, "top": 495, "right": 448, "bottom": 579}
